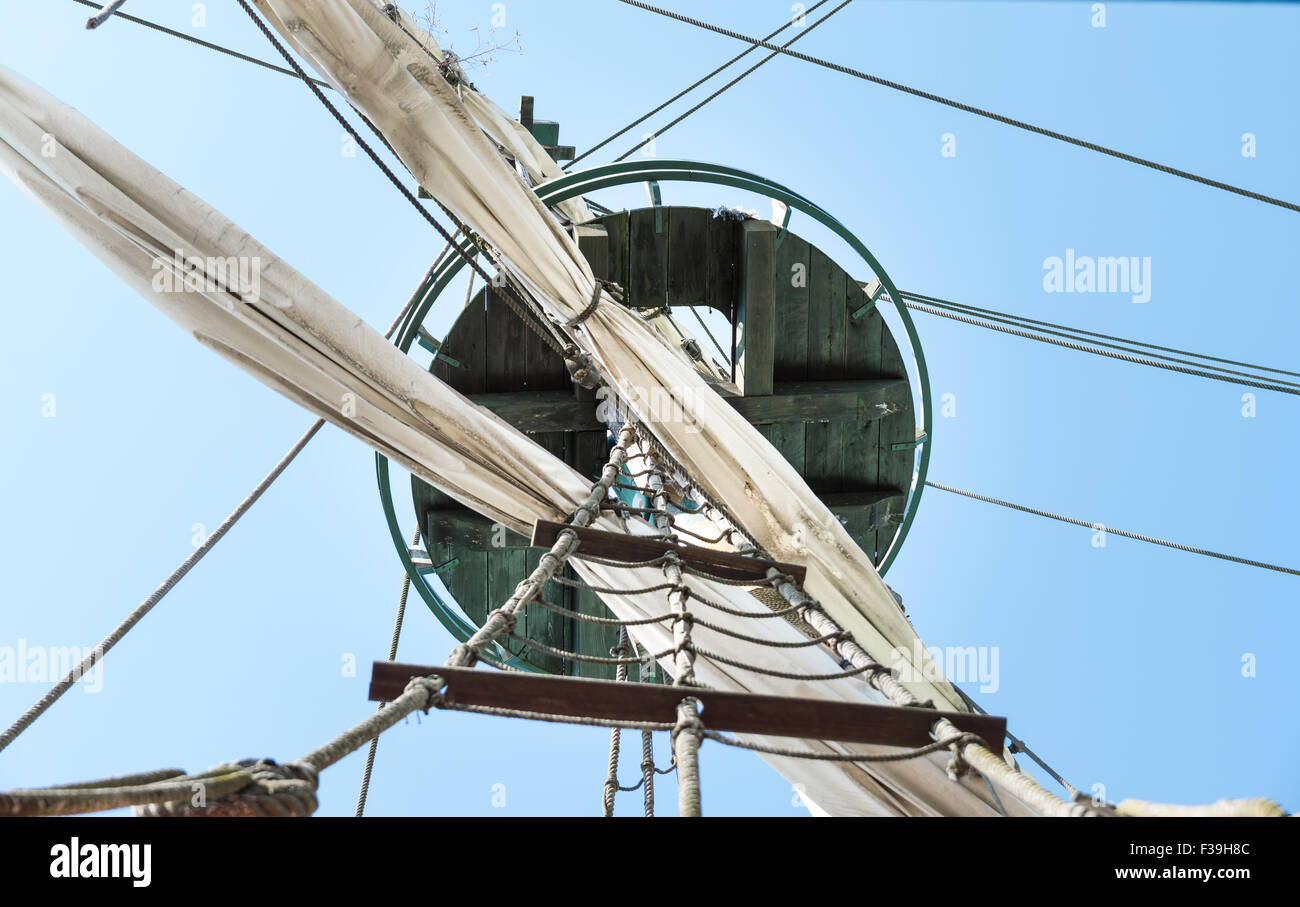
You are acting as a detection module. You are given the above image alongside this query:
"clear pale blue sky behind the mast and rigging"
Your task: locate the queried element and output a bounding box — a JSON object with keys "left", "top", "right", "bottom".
{"left": 0, "top": 0, "right": 1300, "bottom": 816}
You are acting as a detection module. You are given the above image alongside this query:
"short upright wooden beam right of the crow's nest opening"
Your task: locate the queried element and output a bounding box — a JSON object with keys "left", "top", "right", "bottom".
{"left": 733, "top": 221, "right": 776, "bottom": 396}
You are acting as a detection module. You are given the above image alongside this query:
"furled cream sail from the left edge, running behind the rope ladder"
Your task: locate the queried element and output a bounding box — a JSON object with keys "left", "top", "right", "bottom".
{"left": 0, "top": 68, "right": 1023, "bottom": 815}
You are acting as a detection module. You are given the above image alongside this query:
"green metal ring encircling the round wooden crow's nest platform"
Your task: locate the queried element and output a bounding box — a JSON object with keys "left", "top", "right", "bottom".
{"left": 374, "top": 160, "right": 933, "bottom": 652}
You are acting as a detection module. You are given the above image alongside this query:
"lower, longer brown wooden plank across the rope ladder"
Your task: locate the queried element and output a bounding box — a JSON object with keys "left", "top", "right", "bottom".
{"left": 369, "top": 661, "right": 1006, "bottom": 752}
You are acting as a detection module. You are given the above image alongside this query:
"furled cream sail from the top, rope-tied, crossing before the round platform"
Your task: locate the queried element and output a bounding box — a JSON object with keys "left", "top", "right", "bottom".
{"left": 255, "top": 0, "right": 966, "bottom": 711}
